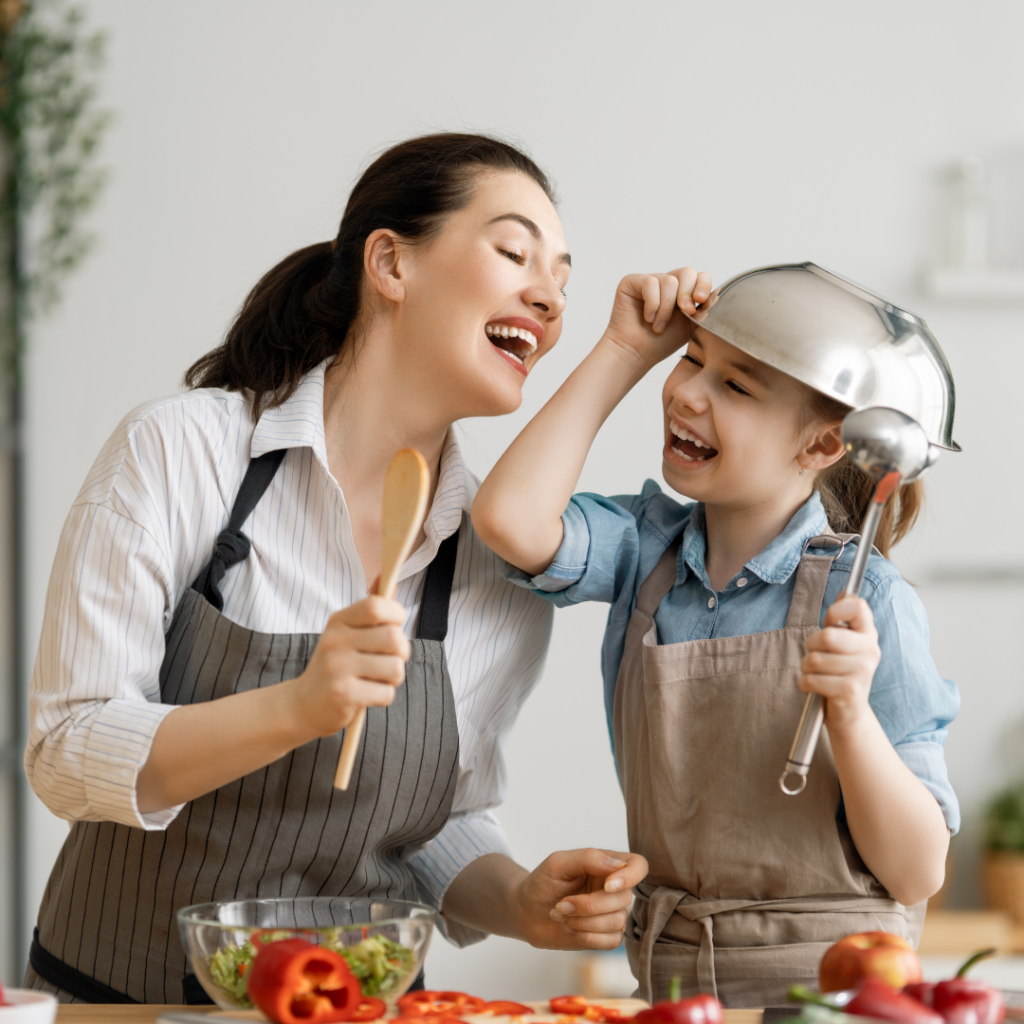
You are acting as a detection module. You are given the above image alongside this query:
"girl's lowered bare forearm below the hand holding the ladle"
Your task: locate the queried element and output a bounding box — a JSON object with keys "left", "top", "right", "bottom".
{"left": 829, "top": 712, "right": 949, "bottom": 906}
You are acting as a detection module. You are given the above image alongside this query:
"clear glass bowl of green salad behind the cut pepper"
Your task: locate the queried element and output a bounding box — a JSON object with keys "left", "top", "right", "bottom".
{"left": 177, "top": 896, "right": 437, "bottom": 1010}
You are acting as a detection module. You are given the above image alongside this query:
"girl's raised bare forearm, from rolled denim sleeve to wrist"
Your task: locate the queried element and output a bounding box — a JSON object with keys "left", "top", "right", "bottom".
{"left": 473, "top": 338, "right": 647, "bottom": 574}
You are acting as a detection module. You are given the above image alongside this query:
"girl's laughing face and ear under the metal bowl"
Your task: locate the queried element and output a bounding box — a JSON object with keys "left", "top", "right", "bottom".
{"left": 662, "top": 328, "right": 843, "bottom": 510}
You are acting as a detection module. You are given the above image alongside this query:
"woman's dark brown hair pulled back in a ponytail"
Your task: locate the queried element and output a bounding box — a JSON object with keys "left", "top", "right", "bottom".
{"left": 184, "top": 132, "right": 555, "bottom": 420}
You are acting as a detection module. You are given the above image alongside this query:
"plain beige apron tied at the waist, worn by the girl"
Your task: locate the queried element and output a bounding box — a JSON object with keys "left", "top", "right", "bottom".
{"left": 613, "top": 534, "right": 925, "bottom": 1007}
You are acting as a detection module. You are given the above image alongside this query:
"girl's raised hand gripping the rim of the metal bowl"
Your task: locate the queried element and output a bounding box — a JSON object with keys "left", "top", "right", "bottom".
{"left": 604, "top": 266, "right": 711, "bottom": 373}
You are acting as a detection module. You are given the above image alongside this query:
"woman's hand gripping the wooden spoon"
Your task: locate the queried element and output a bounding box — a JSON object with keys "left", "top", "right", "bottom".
{"left": 292, "top": 596, "right": 412, "bottom": 736}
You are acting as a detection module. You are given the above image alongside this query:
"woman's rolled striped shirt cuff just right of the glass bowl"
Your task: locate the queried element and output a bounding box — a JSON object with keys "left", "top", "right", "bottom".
{"left": 410, "top": 811, "right": 512, "bottom": 947}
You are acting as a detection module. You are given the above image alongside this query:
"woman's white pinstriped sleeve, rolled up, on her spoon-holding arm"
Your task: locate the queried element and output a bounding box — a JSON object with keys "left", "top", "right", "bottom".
{"left": 25, "top": 503, "right": 181, "bottom": 829}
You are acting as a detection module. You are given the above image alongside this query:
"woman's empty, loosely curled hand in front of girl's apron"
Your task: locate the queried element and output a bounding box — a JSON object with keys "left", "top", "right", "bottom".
{"left": 515, "top": 849, "right": 647, "bottom": 949}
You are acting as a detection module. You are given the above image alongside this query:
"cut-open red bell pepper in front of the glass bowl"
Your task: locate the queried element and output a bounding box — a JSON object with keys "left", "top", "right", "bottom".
{"left": 248, "top": 939, "right": 362, "bottom": 1024}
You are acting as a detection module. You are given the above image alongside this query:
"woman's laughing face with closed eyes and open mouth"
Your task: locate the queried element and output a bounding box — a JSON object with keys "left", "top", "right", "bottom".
{"left": 392, "top": 172, "right": 570, "bottom": 420}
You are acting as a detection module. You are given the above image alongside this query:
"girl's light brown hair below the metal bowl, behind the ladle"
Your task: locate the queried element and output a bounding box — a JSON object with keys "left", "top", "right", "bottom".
{"left": 804, "top": 384, "right": 925, "bottom": 558}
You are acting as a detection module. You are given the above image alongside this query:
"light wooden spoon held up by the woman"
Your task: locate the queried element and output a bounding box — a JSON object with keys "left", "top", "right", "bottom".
{"left": 334, "top": 449, "right": 430, "bottom": 790}
